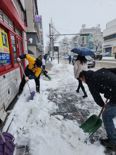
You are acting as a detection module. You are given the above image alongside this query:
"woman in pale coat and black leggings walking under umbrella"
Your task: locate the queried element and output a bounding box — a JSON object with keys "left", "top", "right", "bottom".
{"left": 74, "top": 55, "right": 87, "bottom": 98}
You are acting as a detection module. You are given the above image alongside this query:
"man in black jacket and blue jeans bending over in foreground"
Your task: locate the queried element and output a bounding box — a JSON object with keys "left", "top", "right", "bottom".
{"left": 79, "top": 68, "right": 116, "bottom": 148}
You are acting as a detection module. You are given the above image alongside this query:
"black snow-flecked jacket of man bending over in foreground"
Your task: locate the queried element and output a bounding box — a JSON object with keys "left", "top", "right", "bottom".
{"left": 85, "top": 68, "right": 116, "bottom": 107}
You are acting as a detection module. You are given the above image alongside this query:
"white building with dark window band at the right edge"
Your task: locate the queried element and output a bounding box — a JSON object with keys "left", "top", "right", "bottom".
{"left": 103, "top": 19, "right": 116, "bottom": 56}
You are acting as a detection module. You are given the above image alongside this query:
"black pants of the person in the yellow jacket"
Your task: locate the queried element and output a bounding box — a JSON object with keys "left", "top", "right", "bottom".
{"left": 19, "top": 67, "right": 40, "bottom": 94}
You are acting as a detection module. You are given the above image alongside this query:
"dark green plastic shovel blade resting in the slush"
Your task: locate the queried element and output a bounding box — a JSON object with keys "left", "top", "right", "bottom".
{"left": 80, "top": 115, "right": 102, "bottom": 134}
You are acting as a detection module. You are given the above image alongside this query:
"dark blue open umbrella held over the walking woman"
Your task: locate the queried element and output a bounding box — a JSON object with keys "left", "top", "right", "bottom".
{"left": 71, "top": 47, "right": 95, "bottom": 56}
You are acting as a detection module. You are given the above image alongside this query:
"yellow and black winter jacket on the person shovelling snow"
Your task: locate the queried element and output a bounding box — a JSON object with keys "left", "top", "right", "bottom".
{"left": 20, "top": 54, "right": 42, "bottom": 78}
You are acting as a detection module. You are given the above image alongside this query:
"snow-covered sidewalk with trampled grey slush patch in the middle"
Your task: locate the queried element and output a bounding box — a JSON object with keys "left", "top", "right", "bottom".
{"left": 4, "top": 60, "right": 105, "bottom": 155}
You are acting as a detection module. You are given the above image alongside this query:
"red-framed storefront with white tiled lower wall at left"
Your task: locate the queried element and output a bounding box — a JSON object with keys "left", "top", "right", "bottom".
{"left": 0, "top": 0, "right": 26, "bottom": 121}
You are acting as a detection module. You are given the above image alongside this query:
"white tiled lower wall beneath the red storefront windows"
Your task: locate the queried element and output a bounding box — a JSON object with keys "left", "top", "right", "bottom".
{"left": 0, "top": 68, "right": 21, "bottom": 121}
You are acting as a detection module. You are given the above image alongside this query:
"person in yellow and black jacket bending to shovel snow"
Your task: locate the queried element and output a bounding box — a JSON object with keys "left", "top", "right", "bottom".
{"left": 17, "top": 54, "right": 47, "bottom": 95}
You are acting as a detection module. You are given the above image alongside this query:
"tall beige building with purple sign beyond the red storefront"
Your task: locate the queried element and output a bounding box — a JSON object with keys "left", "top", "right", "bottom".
{"left": 25, "top": 0, "right": 43, "bottom": 57}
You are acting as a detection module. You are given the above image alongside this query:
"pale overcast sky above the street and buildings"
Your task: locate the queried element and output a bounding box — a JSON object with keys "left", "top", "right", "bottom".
{"left": 38, "top": 0, "right": 116, "bottom": 42}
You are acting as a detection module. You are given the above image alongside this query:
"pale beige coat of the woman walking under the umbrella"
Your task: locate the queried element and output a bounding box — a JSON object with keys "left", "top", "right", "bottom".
{"left": 74, "top": 60, "right": 87, "bottom": 79}
